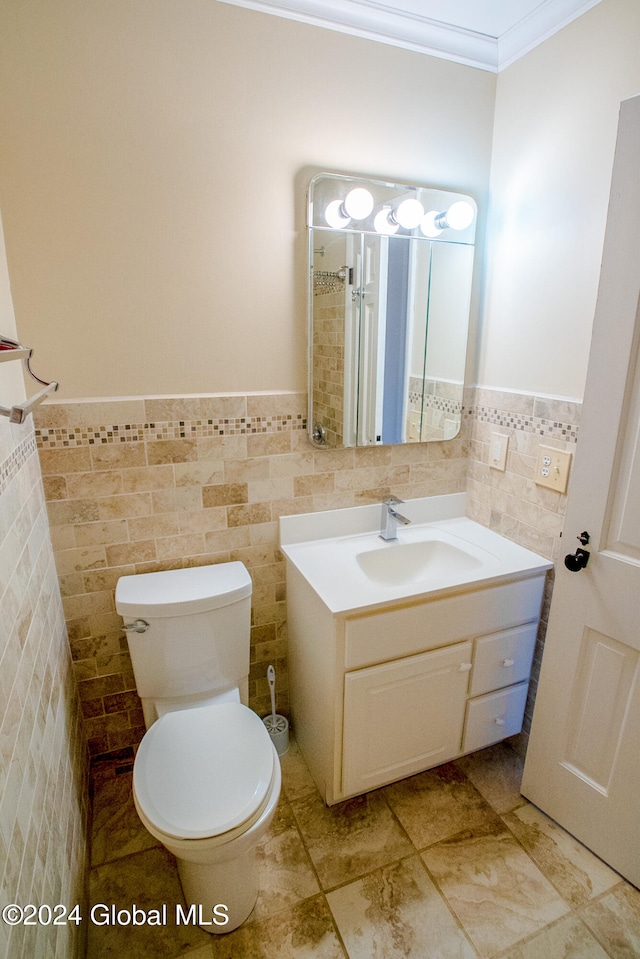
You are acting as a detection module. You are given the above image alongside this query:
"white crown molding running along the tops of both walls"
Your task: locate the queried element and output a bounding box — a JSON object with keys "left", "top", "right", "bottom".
{"left": 212, "top": 0, "right": 600, "bottom": 73}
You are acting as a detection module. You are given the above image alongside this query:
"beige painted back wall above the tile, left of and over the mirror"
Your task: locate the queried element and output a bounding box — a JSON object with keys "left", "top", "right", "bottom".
{"left": 0, "top": 0, "right": 495, "bottom": 398}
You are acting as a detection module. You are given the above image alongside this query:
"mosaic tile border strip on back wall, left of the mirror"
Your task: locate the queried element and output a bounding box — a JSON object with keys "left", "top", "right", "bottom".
{"left": 35, "top": 414, "right": 307, "bottom": 450}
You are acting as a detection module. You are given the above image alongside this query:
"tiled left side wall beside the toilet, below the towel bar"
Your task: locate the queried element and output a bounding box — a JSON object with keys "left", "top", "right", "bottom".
{"left": 0, "top": 418, "right": 89, "bottom": 959}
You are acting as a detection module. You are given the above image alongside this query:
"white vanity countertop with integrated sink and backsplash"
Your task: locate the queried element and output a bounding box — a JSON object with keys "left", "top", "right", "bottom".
{"left": 280, "top": 493, "right": 551, "bottom": 613}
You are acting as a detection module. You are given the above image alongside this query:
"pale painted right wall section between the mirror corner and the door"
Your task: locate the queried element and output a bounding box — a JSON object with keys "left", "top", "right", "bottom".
{"left": 477, "top": 0, "right": 640, "bottom": 399}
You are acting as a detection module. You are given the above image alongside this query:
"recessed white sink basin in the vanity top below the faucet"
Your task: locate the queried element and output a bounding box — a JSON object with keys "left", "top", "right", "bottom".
{"left": 356, "top": 539, "right": 482, "bottom": 586}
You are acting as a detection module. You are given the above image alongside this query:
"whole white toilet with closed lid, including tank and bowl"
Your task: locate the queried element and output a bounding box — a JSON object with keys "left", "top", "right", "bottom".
{"left": 116, "top": 563, "right": 281, "bottom": 933}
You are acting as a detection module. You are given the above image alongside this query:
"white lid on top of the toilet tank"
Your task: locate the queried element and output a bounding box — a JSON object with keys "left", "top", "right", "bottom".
{"left": 116, "top": 562, "right": 252, "bottom": 618}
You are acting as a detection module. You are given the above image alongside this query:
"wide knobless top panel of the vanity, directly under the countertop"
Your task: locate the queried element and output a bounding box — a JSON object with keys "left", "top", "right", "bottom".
{"left": 345, "top": 575, "right": 544, "bottom": 669}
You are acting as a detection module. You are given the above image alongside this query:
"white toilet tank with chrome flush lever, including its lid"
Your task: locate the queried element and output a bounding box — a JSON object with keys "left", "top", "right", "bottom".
{"left": 116, "top": 562, "right": 252, "bottom": 699}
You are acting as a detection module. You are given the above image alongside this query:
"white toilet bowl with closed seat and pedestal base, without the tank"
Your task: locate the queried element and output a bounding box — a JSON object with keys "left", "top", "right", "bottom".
{"left": 133, "top": 703, "right": 281, "bottom": 933}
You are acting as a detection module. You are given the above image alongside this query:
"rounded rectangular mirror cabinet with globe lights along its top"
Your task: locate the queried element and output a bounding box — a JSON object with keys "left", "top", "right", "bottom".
{"left": 307, "top": 173, "right": 477, "bottom": 449}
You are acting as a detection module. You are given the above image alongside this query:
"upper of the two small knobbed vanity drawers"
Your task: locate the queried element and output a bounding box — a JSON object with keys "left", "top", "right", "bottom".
{"left": 469, "top": 621, "right": 538, "bottom": 696}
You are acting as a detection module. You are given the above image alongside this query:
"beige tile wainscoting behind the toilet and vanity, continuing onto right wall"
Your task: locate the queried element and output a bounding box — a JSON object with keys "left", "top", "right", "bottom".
{"left": 31, "top": 390, "right": 578, "bottom": 760}
